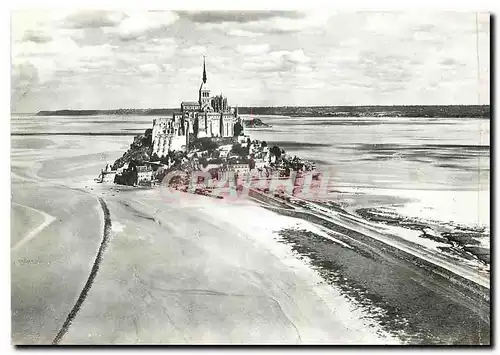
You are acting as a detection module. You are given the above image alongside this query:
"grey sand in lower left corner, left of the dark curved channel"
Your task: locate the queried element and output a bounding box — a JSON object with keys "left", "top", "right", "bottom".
{"left": 11, "top": 182, "right": 102, "bottom": 344}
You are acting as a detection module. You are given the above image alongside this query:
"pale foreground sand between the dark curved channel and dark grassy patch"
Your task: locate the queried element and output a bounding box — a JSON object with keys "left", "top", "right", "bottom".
{"left": 61, "top": 189, "right": 399, "bottom": 344}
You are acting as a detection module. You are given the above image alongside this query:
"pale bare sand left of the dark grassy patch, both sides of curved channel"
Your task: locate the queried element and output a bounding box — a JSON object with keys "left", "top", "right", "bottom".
{"left": 11, "top": 137, "right": 400, "bottom": 344}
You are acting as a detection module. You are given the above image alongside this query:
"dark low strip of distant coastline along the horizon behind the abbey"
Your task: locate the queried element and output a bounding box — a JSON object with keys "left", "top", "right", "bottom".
{"left": 37, "top": 105, "right": 490, "bottom": 118}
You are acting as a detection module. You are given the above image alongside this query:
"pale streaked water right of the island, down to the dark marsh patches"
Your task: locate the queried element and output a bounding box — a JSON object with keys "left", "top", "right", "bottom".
{"left": 247, "top": 116, "right": 490, "bottom": 231}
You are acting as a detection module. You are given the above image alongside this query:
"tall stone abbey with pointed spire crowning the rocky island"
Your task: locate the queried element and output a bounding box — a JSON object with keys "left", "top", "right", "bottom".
{"left": 152, "top": 59, "right": 238, "bottom": 157}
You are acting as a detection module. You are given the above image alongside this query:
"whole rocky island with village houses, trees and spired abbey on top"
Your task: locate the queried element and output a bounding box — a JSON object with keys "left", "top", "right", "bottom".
{"left": 97, "top": 60, "right": 318, "bottom": 195}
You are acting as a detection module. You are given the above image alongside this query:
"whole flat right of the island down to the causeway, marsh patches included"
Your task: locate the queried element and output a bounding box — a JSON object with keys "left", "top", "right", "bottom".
{"left": 248, "top": 116, "right": 490, "bottom": 280}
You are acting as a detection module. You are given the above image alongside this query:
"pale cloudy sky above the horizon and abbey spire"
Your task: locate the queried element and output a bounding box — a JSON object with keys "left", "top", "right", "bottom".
{"left": 11, "top": 9, "right": 490, "bottom": 112}
